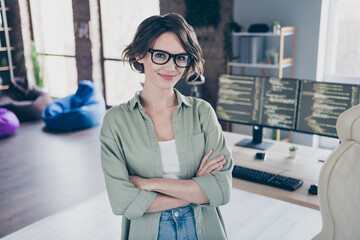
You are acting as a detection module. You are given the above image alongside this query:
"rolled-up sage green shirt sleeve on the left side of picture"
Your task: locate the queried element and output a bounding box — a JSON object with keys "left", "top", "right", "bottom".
{"left": 100, "top": 112, "right": 157, "bottom": 220}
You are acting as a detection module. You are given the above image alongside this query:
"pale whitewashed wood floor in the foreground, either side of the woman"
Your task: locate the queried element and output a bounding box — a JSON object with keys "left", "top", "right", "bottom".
{"left": 3, "top": 189, "right": 321, "bottom": 240}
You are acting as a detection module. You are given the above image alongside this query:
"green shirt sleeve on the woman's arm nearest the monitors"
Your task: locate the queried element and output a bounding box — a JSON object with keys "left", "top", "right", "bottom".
{"left": 194, "top": 103, "right": 234, "bottom": 207}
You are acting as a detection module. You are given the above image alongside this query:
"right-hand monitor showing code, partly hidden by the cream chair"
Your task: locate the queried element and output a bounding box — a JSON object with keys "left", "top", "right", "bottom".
{"left": 296, "top": 80, "right": 359, "bottom": 138}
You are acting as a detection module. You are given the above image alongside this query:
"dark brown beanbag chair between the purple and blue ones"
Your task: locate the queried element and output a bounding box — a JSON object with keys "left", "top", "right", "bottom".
{"left": 0, "top": 78, "right": 52, "bottom": 122}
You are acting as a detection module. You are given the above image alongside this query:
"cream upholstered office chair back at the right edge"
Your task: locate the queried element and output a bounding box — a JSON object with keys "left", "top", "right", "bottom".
{"left": 313, "top": 105, "right": 360, "bottom": 240}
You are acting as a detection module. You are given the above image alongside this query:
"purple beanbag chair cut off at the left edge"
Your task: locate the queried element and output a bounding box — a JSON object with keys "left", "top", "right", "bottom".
{"left": 0, "top": 108, "right": 20, "bottom": 139}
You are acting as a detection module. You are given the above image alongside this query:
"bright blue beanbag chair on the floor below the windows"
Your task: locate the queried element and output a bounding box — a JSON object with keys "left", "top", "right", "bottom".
{"left": 42, "top": 80, "right": 106, "bottom": 131}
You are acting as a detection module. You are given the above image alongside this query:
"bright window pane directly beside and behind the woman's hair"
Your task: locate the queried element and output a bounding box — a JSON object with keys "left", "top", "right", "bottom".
{"left": 100, "top": 0, "right": 160, "bottom": 105}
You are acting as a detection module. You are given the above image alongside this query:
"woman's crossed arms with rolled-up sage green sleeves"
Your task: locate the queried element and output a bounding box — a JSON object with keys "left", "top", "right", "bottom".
{"left": 100, "top": 106, "right": 233, "bottom": 220}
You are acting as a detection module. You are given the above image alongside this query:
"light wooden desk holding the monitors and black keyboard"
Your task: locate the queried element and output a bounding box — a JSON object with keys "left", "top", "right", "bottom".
{"left": 224, "top": 132, "right": 331, "bottom": 210}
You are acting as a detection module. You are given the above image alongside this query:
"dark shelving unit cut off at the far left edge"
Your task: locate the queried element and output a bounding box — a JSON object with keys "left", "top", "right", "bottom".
{"left": 0, "top": 0, "right": 16, "bottom": 90}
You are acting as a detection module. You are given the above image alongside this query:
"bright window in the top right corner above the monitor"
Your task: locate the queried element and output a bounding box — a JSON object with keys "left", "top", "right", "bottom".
{"left": 324, "top": 0, "right": 360, "bottom": 84}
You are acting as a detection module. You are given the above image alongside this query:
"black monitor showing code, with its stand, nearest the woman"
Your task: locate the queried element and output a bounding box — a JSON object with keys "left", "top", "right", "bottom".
{"left": 216, "top": 74, "right": 299, "bottom": 150}
